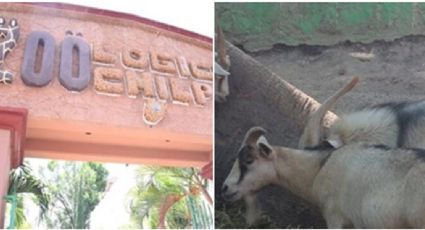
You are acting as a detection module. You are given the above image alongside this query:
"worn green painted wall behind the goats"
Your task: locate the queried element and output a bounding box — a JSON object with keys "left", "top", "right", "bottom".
{"left": 215, "top": 3, "right": 425, "bottom": 51}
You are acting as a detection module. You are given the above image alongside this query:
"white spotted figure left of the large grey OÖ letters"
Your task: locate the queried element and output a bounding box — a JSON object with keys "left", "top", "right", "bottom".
{"left": 0, "top": 17, "right": 20, "bottom": 84}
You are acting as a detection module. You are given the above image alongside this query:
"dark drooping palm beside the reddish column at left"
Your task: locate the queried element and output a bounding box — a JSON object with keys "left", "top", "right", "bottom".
{"left": 8, "top": 164, "right": 50, "bottom": 228}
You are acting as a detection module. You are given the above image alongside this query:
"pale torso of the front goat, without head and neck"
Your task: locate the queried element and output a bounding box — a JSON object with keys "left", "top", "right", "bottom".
{"left": 313, "top": 144, "right": 425, "bottom": 228}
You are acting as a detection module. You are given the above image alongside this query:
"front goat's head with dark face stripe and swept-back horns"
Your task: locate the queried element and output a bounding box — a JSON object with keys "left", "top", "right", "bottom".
{"left": 222, "top": 127, "right": 277, "bottom": 201}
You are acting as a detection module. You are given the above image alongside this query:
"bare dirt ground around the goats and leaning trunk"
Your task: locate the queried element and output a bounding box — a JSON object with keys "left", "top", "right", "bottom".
{"left": 215, "top": 36, "right": 425, "bottom": 228}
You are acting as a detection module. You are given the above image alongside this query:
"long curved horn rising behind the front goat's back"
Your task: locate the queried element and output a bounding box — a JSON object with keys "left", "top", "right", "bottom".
{"left": 298, "top": 76, "right": 359, "bottom": 149}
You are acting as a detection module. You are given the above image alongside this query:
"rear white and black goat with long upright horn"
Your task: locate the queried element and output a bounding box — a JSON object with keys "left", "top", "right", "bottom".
{"left": 298, "top": 77, "right": 425, "bottom": 149}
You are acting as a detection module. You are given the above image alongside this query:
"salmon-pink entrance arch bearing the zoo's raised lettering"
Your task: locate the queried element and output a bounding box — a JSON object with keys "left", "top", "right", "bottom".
{"left": 0, "top": 3, "right": 213, "bottom": 226}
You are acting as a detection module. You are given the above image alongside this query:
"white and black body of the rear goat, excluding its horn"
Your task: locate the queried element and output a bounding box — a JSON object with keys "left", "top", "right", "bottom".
{"left": 328, "top": 101, "right": 425, "bottom": 148}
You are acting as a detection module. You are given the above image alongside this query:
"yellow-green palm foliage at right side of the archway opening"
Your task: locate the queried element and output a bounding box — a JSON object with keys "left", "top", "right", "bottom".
{"left": 129, "top": 166, "right": 211, "bottom": 229}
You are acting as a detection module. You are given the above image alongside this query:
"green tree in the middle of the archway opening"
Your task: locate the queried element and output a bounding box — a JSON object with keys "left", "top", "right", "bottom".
{"left": 41, "top": 161, "right": 108, "bottom": 228}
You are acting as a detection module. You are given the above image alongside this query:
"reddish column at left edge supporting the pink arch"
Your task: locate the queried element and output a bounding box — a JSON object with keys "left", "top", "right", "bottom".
{"left": 0, "top": 107, "right": 27, "bottom": 228}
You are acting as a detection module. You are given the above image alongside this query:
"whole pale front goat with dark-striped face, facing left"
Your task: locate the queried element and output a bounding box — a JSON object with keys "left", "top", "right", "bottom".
{"left": 222, "top": 127, "right": 425, "bottom": 228}
